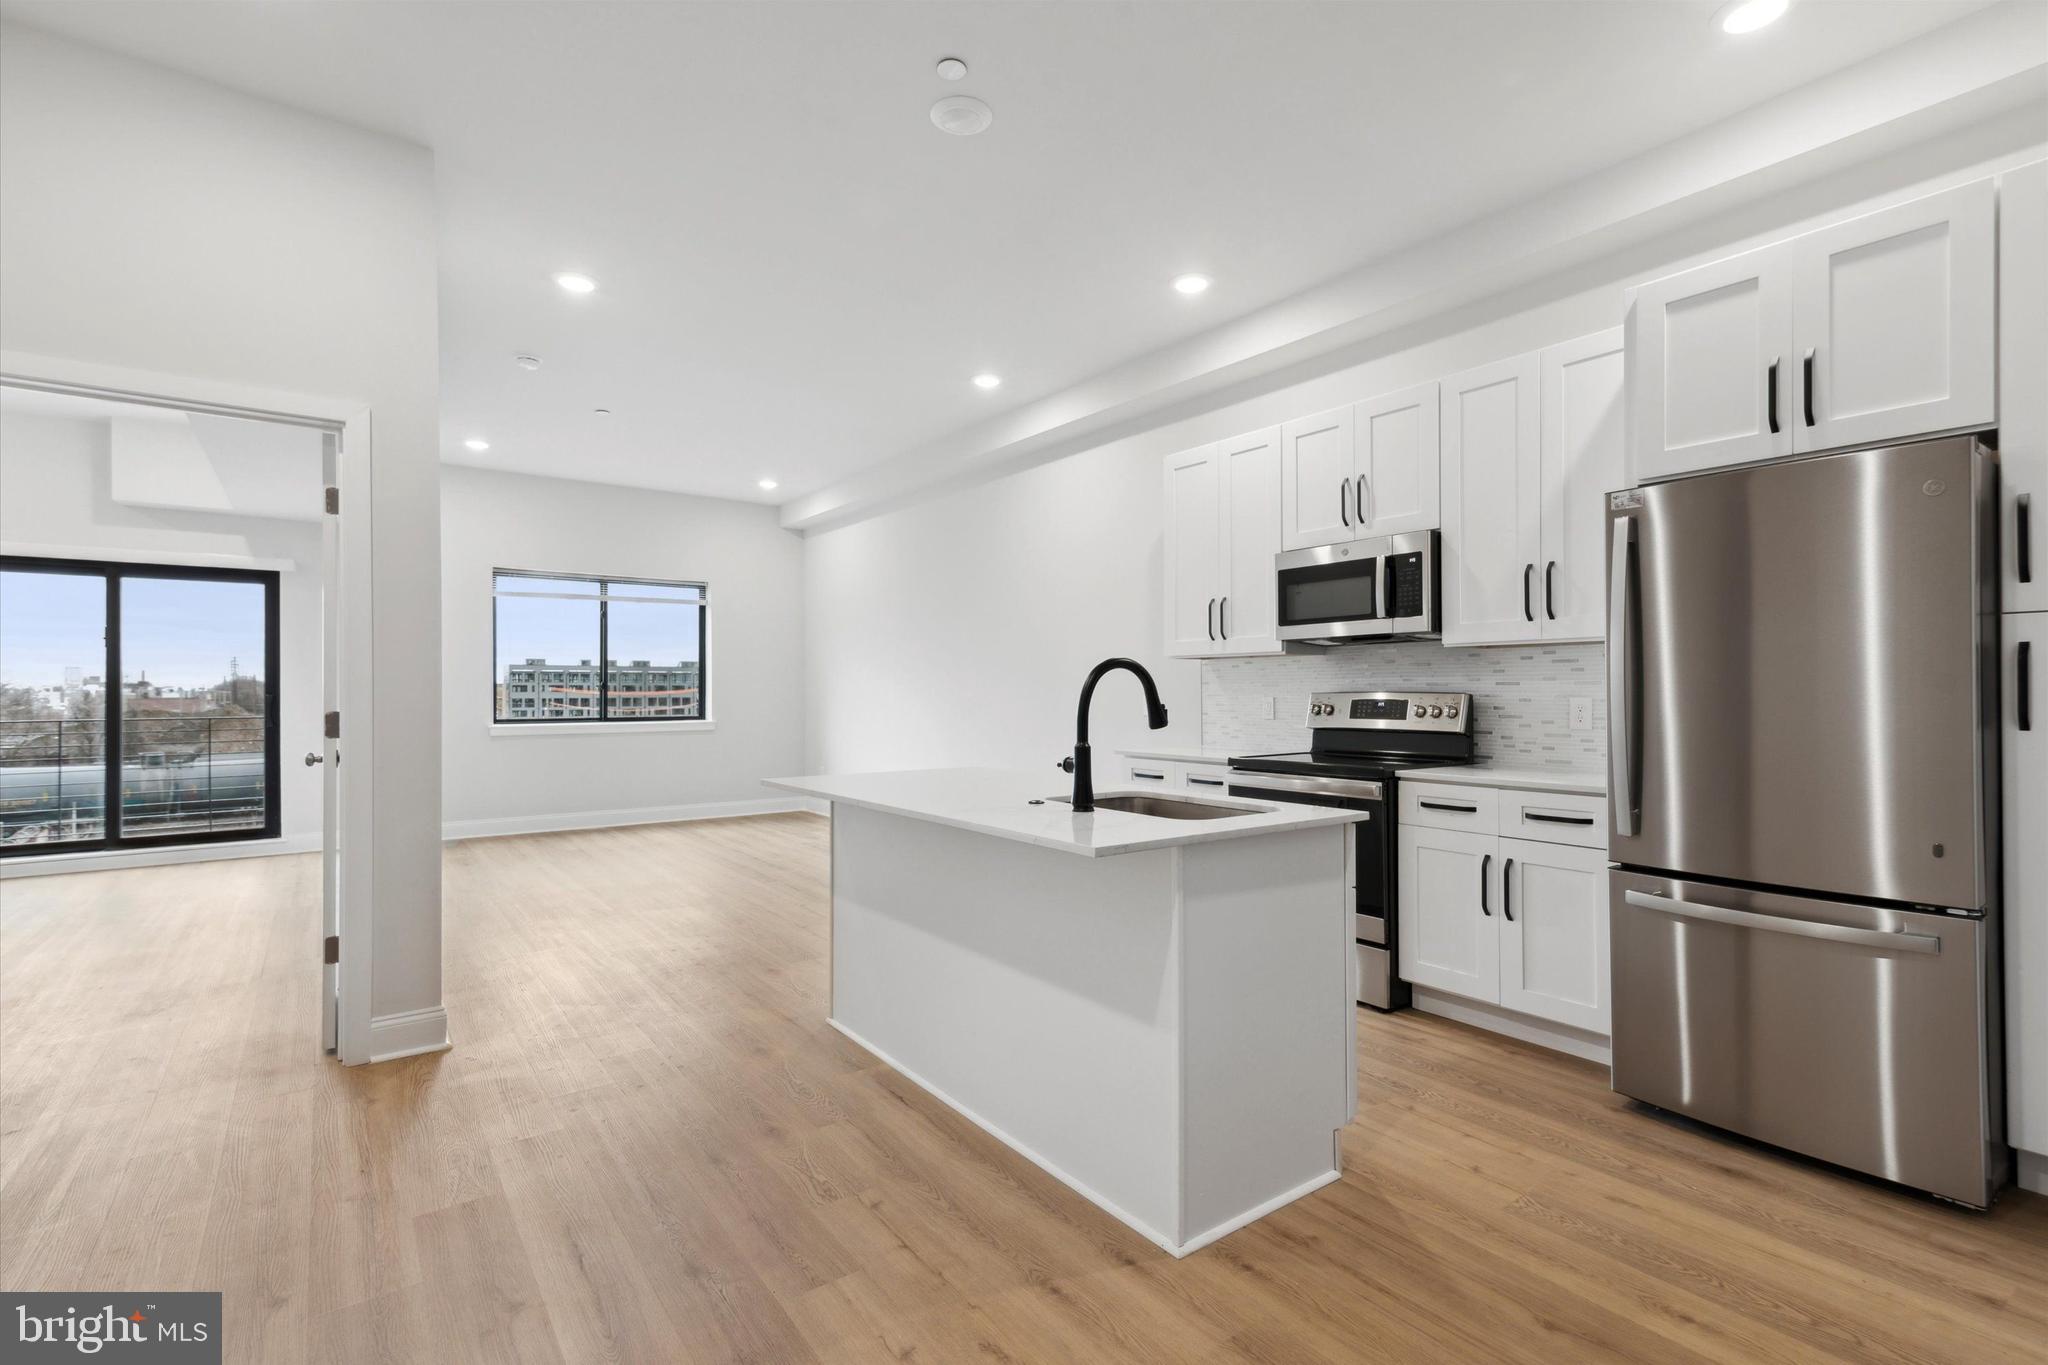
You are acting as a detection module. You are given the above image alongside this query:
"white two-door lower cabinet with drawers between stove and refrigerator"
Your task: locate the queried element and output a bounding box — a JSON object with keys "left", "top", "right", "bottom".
{"left": 1397, "top": 782, "right": 1610, "bottom": 1036}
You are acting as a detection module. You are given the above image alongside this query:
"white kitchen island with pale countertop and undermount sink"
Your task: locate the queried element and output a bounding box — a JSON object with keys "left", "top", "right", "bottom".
{"left": 768, "top": 769, "right": 1360, "bottom": 1257}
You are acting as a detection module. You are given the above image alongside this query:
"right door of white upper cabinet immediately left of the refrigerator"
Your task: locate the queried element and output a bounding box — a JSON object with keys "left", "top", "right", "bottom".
{"left": 1538, "top": 327, "right": 1628, "bottom": 641}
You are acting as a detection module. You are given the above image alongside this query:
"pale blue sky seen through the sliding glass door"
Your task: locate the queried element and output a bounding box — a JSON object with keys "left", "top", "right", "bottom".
{"left": 0, "top": 573, "right": 264, "bottom": 688}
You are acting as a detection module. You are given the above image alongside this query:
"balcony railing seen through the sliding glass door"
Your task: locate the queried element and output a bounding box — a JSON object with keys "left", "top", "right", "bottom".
{"left": 0, "top": 716, "right": 270, "bottom": 845}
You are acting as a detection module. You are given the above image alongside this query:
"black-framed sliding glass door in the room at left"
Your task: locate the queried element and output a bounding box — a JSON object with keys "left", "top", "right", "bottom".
{"left": 0, "top": 557, "right": 279, "bottom": 857}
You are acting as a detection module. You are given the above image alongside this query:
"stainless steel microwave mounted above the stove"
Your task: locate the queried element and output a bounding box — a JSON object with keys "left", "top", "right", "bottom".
{"left": 1274, "top": 530, "right": 1442, "bottom": 645}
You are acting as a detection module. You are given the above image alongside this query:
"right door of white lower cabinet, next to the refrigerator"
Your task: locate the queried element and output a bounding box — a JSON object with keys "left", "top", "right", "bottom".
{"left": 1499, "top": 839, "right": 1608, "bottom": 1033}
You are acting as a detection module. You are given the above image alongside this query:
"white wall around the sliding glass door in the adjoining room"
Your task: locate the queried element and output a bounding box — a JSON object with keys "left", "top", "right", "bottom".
{"left": 0, "top": 411, "right": 322, "bottom": 847}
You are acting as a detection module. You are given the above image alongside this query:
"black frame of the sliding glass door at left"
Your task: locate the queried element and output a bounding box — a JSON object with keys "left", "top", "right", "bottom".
{"left": 0, "top": 555, "right": 285, "bottom": 857}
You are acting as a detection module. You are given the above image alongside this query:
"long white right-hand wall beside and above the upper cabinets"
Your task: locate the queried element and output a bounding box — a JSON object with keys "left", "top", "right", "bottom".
{"left": 805, "top": 121, "right": 2048, "bottom": 778}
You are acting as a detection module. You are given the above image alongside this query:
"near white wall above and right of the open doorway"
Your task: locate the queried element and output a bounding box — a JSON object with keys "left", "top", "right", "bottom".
{"left": 0, "top": 25, "right": 440, "bottom": 1015}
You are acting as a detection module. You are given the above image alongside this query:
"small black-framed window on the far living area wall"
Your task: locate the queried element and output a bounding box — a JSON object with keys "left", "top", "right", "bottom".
{"left": 492, "top": 569, "right": 711, "bottom": 724}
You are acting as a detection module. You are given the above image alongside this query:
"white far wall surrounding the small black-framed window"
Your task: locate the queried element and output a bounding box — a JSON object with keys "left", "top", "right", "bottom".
{"left": 440, "top": 465, "right": 803, "bottom": 837}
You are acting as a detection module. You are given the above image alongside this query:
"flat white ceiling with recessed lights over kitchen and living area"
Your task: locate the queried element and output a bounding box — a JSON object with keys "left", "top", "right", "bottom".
{"left": 0, "top": 0, "right": 1982, "bottom": 501}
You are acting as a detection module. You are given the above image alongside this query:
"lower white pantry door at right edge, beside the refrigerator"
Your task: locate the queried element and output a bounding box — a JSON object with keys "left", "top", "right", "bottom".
{"left": 1999, "top": 612, "right": 2048, "bottom": 1154}
